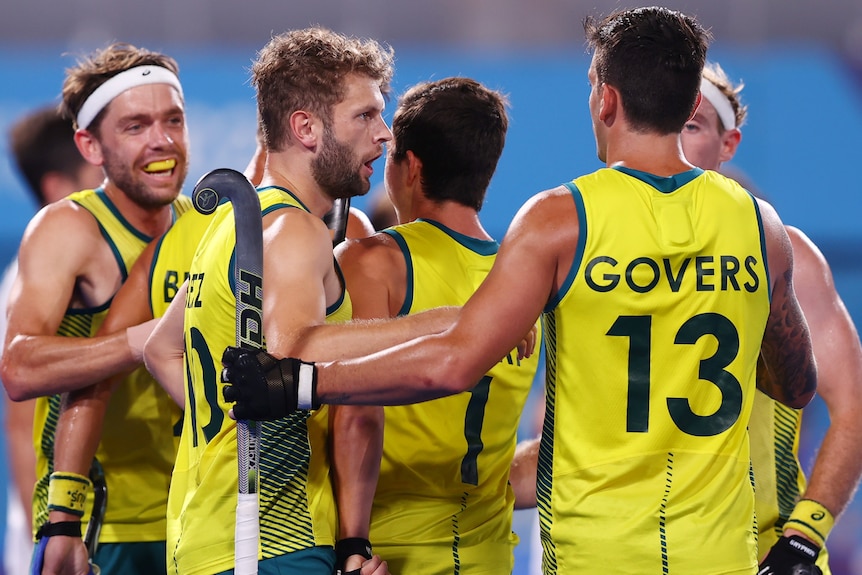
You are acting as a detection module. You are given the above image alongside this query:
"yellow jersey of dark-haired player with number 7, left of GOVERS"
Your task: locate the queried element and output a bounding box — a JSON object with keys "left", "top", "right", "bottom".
{"left": 370, "top": 220, "right": 538, "bottom": 575}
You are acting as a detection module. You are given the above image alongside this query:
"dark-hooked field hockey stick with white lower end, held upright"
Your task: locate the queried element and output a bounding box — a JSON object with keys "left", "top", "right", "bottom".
{"left": 192, "top": 168, "right": 263, "bottom": 575}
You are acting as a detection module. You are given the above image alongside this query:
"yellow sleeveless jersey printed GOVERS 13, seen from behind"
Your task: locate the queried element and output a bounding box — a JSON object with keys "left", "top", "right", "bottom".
{"left": 537, "top": 169, "right": 770, "bottom": 575}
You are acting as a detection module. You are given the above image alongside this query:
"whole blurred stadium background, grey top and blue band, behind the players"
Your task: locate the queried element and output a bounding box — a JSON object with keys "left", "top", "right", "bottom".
{"left": 0, "top": 0, "right": 862, "bottom": 575}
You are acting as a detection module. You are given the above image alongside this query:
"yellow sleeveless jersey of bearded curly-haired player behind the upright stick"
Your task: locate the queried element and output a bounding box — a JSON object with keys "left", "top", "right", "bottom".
{"left": 168, "top": 188, "right": 352, "bottom": 575}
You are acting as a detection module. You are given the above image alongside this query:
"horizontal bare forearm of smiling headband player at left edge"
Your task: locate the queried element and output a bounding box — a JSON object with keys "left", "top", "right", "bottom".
{"left": 2, "top": 332, "right": 139, "bottom": 401}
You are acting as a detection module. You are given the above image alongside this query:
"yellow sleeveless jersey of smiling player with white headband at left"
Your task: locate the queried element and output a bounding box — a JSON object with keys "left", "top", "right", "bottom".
{"left": 33, "top": 189, "right": 191, "bottom": 543}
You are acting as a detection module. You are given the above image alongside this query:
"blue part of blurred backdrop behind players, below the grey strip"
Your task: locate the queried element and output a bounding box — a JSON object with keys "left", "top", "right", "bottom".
{"left": 0, "top": 43, "right": 862, "bottom": 575}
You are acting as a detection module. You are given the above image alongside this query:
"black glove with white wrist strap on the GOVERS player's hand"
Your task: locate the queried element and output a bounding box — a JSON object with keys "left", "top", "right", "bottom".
{"left": 221, "top": 347, "right": 319, "bottom": 421}
